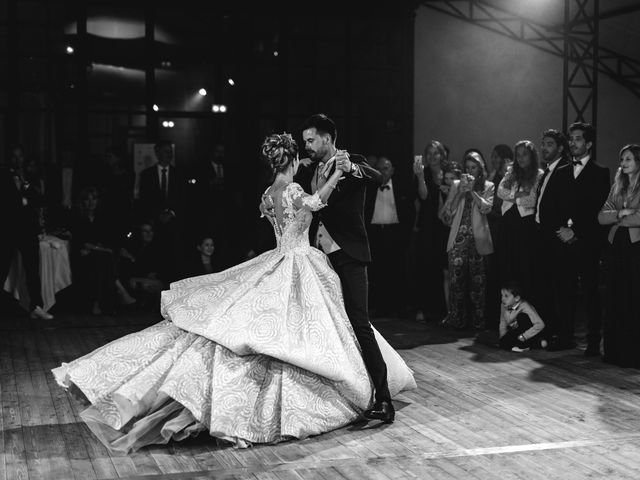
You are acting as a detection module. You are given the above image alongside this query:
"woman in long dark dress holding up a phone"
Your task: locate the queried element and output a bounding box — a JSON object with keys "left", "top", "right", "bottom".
{"left": 410, "top": 140, "right": 447, "bottom": 321}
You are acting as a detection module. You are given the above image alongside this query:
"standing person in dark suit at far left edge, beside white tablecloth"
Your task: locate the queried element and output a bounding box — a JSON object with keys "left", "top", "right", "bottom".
{"left": 0, "top": 146, "right": 53, "bottom": 320}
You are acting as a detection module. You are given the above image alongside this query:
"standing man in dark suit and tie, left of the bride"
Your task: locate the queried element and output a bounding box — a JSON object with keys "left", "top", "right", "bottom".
{"left": 138, "top": 141, "right": 187, "bottom": 280}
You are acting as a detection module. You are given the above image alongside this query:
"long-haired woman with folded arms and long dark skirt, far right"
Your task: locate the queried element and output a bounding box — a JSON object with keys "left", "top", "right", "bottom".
{"left": 598, "top": 145, "right": 640, "bottom": 368}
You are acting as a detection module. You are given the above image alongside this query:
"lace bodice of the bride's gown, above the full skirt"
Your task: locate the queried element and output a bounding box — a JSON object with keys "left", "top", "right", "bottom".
{"left": 265, "top": 182, "right": 326, "bottom": 251}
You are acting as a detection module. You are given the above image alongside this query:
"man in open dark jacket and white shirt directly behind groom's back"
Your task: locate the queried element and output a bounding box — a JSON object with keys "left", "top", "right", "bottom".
{"left": 365, "top": 156, "right": 413, "bottom": 315}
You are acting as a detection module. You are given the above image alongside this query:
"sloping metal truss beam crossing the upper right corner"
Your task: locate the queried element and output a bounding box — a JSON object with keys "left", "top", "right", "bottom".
{"left": 421, "top": 0, "right": 640, "bottom": 106}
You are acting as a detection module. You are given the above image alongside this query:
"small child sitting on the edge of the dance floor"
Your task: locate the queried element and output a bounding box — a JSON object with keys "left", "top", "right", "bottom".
{"left": 499, "top": 282, "right": 547, "bottom": 352}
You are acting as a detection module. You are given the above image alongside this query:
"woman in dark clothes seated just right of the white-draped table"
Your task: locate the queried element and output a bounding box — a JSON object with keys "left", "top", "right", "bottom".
{"left": 71, "top": 187, "right": 123, "bottom": 315}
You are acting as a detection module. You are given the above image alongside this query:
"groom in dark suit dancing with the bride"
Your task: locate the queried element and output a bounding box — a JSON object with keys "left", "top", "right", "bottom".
{"left": 295, "top": 114, "right": 395, "bottom": 423}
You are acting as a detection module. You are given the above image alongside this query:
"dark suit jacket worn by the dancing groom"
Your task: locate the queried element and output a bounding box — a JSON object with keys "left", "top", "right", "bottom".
{"left": 295, "top": 154, "right": 382, "bottom": 262}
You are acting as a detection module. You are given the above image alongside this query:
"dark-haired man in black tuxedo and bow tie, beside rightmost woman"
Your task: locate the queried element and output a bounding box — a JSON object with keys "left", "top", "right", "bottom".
{"left": 559, "top": 122, "right": 610, "bottom": 356}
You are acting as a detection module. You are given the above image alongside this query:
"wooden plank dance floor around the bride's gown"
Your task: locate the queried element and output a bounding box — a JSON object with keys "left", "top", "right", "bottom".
{"left": 0, "top": 308, "right": 640, "bottom": 480}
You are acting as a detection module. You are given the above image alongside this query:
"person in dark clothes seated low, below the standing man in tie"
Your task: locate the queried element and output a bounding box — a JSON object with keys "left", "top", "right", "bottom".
{"left": 118, "top": 220, "right": 169, "bottom": 306}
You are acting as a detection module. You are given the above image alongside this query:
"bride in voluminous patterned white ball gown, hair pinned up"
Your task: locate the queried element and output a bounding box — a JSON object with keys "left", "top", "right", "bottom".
{"left": 53, "top": 134, "right": 416, "bottom": 453}
